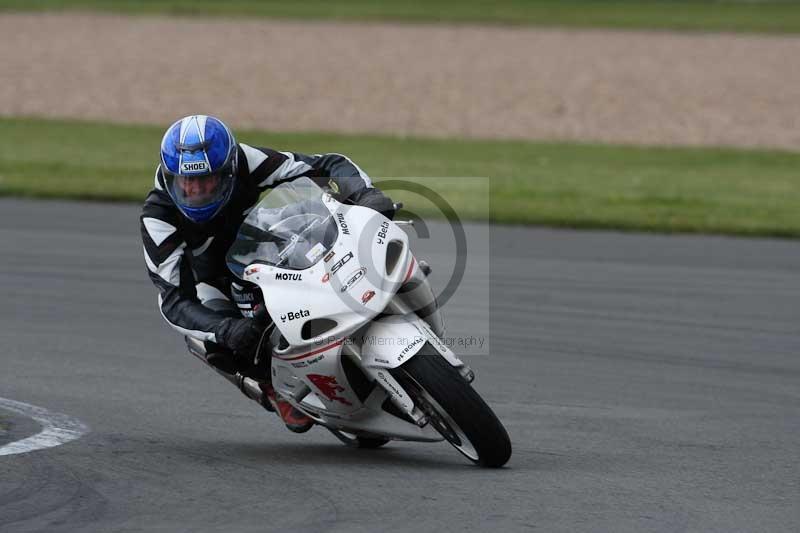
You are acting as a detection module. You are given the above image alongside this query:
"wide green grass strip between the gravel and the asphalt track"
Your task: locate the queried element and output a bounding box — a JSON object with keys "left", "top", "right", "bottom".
{"left": 0, "top": 118, "right": 800, "bottom": 238}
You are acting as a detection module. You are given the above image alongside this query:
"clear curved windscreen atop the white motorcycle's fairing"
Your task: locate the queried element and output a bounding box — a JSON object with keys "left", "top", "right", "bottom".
{"left": 226, "top": 178, "right": 339, "bottom": 279}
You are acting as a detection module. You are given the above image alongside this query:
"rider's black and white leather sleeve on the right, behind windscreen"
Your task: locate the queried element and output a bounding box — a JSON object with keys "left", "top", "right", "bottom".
{"left": 239, "top": 144, "right": 394, "bottom": 218}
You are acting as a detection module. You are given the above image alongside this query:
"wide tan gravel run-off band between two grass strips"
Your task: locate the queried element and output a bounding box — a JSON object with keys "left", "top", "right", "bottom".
{"left": 0, "top": 13, "right": 800, "bottom": 150}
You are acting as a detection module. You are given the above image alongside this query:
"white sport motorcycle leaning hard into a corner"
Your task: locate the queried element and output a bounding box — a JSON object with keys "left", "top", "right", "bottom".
{"left": 190, "top": 178, "right": 511, "bottom": 467}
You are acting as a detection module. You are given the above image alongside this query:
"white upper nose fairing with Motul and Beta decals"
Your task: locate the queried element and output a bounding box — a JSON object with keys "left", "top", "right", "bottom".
{"left": 243, "top": 191, "right": 416, "bottom": 350}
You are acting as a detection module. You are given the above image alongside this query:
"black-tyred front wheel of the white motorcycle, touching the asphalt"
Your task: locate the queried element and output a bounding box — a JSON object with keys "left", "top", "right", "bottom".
{"left": 391, "top": 344, "right": 511, "bottom": 468}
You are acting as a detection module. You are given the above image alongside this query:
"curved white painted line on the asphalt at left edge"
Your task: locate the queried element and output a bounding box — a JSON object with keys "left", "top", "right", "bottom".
{"left": 0, "top": 398, "right": 89, "bottom": 455}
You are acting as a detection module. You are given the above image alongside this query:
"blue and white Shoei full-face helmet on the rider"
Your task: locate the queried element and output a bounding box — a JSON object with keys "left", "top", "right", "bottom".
{"left": 161, "top": 115, "right": 237, "bottom": 223}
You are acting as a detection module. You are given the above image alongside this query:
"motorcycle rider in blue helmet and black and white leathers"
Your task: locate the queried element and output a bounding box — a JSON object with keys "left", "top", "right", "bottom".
{"left": 140, "top": 115, "right": 394, "bottom": 432}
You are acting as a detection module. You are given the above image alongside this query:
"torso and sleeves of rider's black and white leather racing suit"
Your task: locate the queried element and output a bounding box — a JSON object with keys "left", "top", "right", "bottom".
{"left": 140, "top": 143, "right": 393, "bottom": 350}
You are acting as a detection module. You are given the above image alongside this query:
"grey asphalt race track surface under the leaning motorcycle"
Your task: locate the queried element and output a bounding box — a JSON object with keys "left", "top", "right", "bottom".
{"left": 0, "top": 199, "right": 800, "bottom": 533}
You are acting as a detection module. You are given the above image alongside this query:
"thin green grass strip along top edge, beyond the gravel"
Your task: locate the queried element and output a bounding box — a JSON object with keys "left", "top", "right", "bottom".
{"left": 0, "top": 0, "right": 800, "bottom": 33}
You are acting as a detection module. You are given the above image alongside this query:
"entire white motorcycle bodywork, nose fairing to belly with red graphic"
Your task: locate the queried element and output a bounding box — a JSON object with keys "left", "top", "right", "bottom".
{"left": 234, "top": 185, "right": 466, "bottom": 441}
